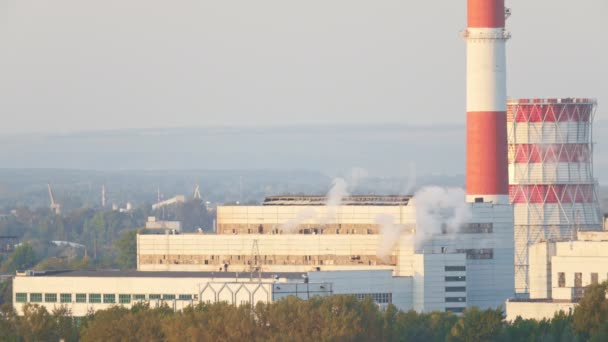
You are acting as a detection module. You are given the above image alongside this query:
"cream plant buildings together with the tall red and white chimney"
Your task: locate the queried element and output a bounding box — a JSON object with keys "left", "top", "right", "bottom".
{"left": 13, "top": 0, "right": 514, "bottom": 313}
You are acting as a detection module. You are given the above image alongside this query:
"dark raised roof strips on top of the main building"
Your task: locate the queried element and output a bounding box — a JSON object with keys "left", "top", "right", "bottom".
{"left": 262, "top": 195, "right": 412, "bottom": 205}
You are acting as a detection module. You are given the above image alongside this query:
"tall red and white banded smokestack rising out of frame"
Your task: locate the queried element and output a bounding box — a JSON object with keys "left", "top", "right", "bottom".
{"left": 463, "top": 0, "right": 510, "bottom": 203}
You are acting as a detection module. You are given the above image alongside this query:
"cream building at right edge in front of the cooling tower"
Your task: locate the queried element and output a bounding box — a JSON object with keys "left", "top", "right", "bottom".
{"left": 506, "top": 231, "right": 608, "bottom": 320}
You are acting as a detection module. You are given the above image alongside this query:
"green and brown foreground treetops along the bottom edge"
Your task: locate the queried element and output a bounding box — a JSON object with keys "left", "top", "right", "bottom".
{"left": 5, "top": 284, "right": 608, "bottom": 342}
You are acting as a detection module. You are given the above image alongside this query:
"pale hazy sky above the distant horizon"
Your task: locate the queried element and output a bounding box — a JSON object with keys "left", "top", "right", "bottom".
{"left": 0, "top": 0, "right": 608, "bottom": 134}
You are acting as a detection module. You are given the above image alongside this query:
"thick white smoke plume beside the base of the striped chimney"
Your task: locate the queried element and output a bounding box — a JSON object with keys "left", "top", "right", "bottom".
{"left": 414, "top": 186, "right": 473, "bottom": 247}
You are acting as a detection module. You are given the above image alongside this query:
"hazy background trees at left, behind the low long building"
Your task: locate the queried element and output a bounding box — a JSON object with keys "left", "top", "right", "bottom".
{"left": 0, "top": 199, "right": 215, "bottom": 272}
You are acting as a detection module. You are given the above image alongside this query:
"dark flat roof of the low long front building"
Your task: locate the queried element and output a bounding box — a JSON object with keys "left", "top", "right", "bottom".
{"left": 17, "top": 270, "right": 307, "bottom": 279}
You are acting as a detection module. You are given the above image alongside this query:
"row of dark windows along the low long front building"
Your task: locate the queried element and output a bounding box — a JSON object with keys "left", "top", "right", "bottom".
{"left": 15, "top": 293, "right": 195, "bottom": 304}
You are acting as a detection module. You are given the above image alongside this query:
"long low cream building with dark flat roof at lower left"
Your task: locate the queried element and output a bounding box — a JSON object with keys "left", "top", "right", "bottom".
{"left": 13, "top": 271, "right": 330, "bottom": 317}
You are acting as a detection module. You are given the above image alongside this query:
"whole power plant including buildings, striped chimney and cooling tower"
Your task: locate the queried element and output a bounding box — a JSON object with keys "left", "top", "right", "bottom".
{"left": 14, "top": 0, "right": 608, "bottom": 317}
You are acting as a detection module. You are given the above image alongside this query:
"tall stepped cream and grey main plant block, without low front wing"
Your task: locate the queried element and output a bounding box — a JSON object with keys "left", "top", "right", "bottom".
{"left": 137, "top": 196, "right": 514, "bottom": 311}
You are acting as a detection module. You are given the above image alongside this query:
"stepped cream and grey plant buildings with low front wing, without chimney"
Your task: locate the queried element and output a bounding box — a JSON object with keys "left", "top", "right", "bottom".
{"left": 13, "top": 198, "right": 513, "bottom": 315}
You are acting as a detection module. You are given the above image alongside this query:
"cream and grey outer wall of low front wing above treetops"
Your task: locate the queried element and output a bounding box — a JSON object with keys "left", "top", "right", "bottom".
{"left": 13, "top": 270, "right": 412, "bottom": 316}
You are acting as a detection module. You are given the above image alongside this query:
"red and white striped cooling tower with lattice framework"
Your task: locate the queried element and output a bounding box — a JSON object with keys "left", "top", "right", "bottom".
{"left": 507, "top": 98, "right": 602, "bottom": 296}
